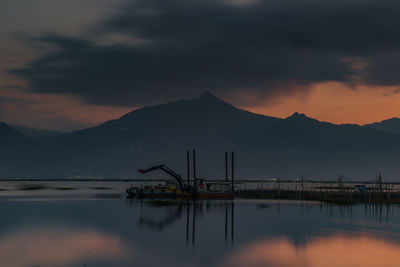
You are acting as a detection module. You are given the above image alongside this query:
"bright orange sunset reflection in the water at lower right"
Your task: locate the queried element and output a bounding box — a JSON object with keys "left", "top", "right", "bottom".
{"left": 227, "top": 237, "right": 400, "bottom": 267}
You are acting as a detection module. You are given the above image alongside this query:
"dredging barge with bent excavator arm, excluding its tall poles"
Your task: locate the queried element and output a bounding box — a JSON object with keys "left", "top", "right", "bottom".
{"left": 126, "top": 165, "right": 233, "bottom": 199}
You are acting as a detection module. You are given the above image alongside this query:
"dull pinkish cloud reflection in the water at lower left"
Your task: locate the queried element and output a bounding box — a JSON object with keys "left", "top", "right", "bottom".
{"left": 0, "top": 228, "right": 128, "bottom": 267}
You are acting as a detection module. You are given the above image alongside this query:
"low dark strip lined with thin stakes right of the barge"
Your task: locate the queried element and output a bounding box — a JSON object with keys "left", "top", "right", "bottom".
{"left": 124, "top": 179, "right": 400, "bottom": 204}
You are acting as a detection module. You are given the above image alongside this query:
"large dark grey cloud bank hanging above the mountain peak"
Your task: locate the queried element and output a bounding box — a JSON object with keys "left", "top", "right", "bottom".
{"left": 11, "top": 0, "right": 400, "bottom": 106}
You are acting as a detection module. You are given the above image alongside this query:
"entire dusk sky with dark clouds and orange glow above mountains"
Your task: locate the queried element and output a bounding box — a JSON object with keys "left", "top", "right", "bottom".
{"left": 0, "top": 0, "right": 400, "bottom": 131}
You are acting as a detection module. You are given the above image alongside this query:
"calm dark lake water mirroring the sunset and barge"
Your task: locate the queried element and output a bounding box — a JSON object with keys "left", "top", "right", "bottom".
{"left": 0, "top": 182, "right": 400, "bottom": 267}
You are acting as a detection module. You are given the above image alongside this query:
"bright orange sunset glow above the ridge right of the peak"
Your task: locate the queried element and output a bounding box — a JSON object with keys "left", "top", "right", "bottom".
{"left": 244, "top": 82, "right": 400, "bottom": 124}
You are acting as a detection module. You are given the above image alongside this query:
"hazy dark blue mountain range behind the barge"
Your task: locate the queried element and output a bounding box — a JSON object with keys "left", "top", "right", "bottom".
{"left": 0, "top": 93, "right": 400, "bottom": 181}
